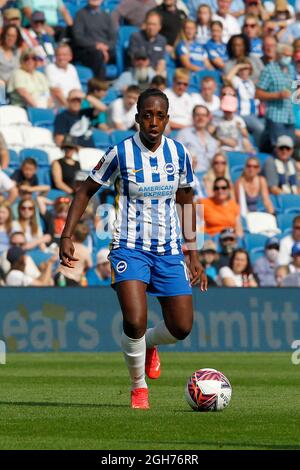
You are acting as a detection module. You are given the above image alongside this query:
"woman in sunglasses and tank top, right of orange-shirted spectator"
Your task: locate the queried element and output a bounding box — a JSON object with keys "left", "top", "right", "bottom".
{"left": 234, "top": 157, "right": 275, "bottom": 215}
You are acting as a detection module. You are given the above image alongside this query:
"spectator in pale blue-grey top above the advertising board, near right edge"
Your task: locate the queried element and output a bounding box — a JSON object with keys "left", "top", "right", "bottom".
{"left": 253, "top": 237, "right": 280, "bottom": 287}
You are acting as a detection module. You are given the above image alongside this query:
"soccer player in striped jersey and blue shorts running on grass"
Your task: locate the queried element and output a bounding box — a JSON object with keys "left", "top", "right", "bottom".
{"left": 60, "top": 89, "right": 207, "bottom": 408}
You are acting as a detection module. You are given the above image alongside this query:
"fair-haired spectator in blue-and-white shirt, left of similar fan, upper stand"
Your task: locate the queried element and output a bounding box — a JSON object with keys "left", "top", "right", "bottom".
{"left": 176, "top": 19, "right": 212, "bottom": 72}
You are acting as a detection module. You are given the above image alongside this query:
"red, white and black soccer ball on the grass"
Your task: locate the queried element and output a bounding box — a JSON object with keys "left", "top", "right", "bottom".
{"left": 185, "top": 369, "right": 232, "bottom": 411}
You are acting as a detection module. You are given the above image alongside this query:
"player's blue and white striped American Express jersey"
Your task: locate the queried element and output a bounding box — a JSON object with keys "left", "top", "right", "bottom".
{"left": 90, "top": 133, "right": 193, "bottom": 254}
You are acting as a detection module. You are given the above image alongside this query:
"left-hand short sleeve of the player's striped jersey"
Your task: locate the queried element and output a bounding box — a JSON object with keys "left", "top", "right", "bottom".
{"left": 89, "top": 147, "right": 120, "bottom": 187}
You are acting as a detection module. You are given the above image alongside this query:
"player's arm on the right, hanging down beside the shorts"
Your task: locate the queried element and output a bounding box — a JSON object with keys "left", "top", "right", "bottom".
{"left": 176, "top": 186, "right": 207, "bottom": 291}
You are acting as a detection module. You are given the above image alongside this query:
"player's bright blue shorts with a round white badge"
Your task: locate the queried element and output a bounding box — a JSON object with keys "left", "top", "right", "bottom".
{"left": 109, "top": 248, "right": 192, "bottom": 297}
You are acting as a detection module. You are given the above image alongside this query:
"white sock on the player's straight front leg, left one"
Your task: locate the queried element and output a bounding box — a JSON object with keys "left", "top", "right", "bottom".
{"left": 121, "top": 333, "right": 147, "bottom": 390}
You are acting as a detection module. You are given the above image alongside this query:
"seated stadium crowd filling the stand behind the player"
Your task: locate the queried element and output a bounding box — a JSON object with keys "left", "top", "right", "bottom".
{"left": 0, "top": 0, "right": 300, "bottom": 287}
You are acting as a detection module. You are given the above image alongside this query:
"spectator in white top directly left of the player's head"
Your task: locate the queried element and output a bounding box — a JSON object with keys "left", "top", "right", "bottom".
{"left": 109, "top": 85, "right": 140, "bottom": 130}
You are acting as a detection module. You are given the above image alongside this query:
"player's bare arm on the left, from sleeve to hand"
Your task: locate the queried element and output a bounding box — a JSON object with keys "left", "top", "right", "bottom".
{"left": 59, "top": 177, "right": 101, "bottom": 268}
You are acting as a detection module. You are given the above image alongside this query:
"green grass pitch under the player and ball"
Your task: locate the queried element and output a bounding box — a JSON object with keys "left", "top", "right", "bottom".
{"left": 0, "top": 353, "right": 300, "bottom": 450}
